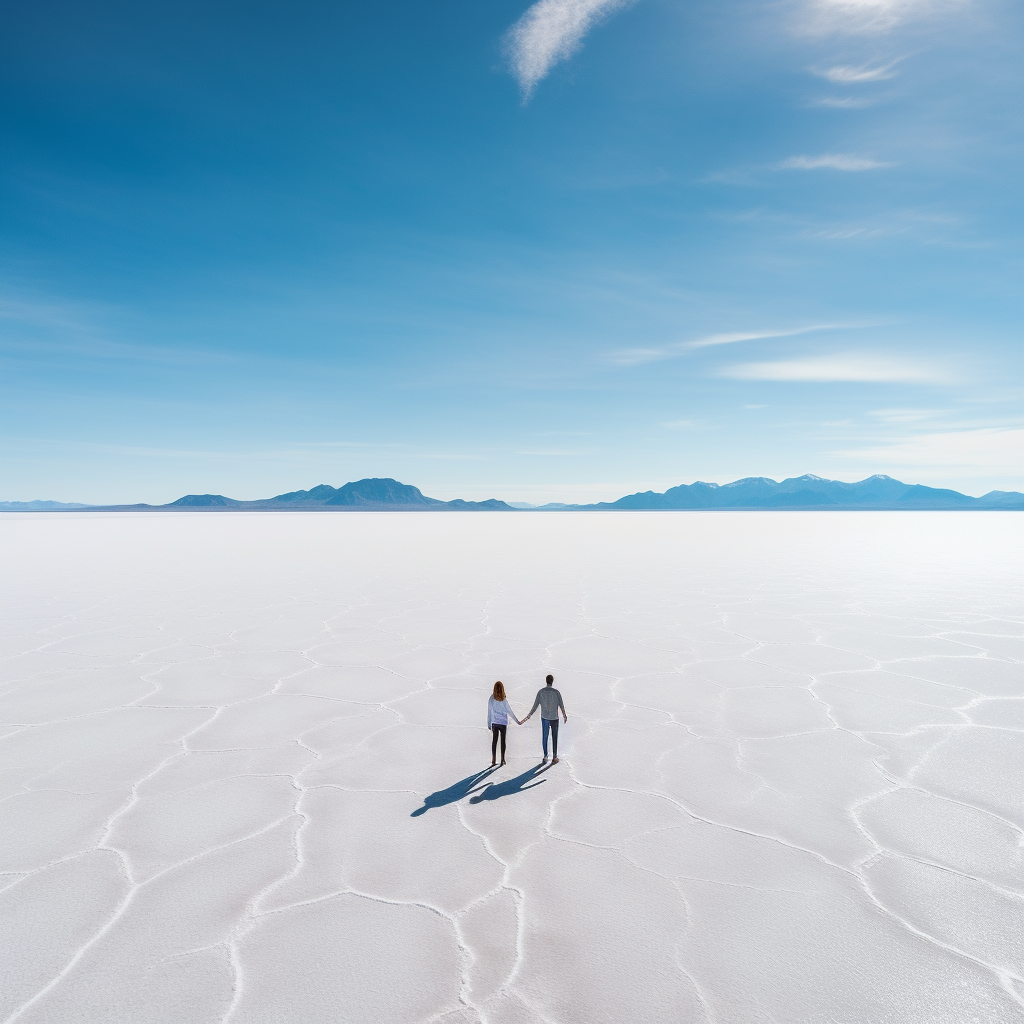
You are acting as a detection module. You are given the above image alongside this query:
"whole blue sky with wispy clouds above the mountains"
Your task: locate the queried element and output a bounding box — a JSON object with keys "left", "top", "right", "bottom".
{"left": 0, "top": 0, "right": 1024, "bottom": 502}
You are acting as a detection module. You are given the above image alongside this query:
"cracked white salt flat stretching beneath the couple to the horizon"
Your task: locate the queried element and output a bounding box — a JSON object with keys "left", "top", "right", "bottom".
{"left": 0, "top": 512, "right": 1024, "bottom": 1024}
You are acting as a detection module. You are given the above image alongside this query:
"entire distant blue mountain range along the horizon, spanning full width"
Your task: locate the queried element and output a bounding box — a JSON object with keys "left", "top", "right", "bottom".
{"left": 0, "top": 473, "right": 1024, "bottom": 512}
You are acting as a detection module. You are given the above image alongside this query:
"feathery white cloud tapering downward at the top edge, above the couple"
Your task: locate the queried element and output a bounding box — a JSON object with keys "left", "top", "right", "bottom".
{"left": 505, "top": 0, "right": 633, "bottom": 99}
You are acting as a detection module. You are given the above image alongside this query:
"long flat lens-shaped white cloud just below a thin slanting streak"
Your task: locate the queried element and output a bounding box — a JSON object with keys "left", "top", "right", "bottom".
{"left": 719, "top": 352, "right": 954, "bottom": 384}
